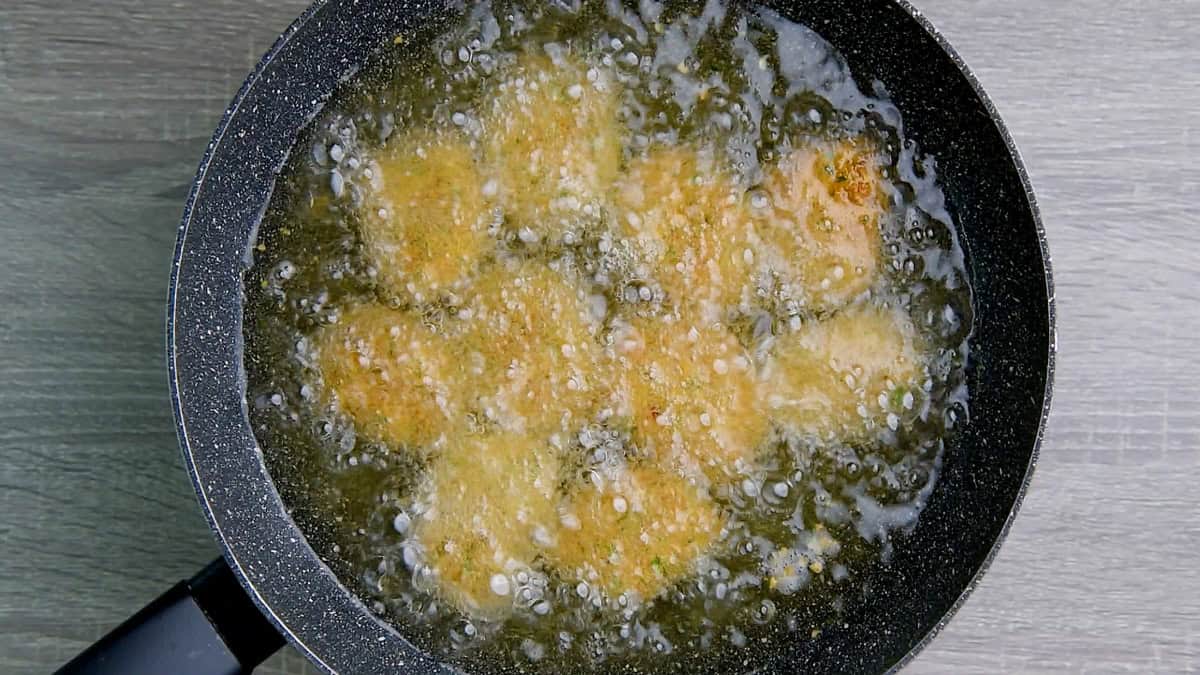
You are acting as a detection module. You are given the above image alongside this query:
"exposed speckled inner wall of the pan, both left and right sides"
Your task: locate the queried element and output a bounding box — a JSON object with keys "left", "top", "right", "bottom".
{"left": 173, "top": 1, "right": 1049, "bottom": 671}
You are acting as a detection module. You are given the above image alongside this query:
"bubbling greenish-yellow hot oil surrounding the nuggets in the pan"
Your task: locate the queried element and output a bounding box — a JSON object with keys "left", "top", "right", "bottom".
{"left": 246, "top": 1, "right": 972, "bottom": 671}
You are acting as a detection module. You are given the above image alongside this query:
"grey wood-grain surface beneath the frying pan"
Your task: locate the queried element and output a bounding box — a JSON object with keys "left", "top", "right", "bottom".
{"left": 0, "top": 0, "right": 1200, "bottom": 674}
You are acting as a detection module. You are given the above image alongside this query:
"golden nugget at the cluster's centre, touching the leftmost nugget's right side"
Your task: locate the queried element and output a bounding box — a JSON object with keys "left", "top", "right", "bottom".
{"left": 458, "top": 262, "right": 610, "bottom": 432}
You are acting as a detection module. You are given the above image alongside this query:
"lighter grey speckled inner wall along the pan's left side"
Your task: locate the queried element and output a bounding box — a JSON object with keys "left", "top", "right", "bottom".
{"left": 174, "top": 0, "right": 451, "bottom": 673}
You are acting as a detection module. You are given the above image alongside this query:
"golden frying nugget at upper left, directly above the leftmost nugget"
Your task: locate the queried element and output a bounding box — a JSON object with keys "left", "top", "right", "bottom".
{"left": 362, "top": 127, "right": 493, "bottom": 303}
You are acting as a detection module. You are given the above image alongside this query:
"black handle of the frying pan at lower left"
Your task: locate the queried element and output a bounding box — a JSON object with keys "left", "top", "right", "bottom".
{"left": 58, "top": 558, "right": 283, "bottom": 675}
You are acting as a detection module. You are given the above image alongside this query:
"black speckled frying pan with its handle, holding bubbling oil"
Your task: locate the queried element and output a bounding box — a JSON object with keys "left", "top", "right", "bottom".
{"left": 61, "top": 0, "right": 1055, "bottom": 674}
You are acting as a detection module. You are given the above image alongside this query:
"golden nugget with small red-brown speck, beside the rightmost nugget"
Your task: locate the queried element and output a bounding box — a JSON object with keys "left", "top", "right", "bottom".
{"left": 617, "top": 318, "right": 769, "bottom": 483}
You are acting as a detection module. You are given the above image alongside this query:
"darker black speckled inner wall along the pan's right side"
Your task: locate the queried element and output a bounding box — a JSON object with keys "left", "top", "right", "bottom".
{"left": 769, "top": 1, "right": 1051, "bottom": 671}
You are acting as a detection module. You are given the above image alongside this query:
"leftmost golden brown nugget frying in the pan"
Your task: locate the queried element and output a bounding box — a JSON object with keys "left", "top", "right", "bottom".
{"left": 314, "top": 305, "right": 467, "bottom": 449}
